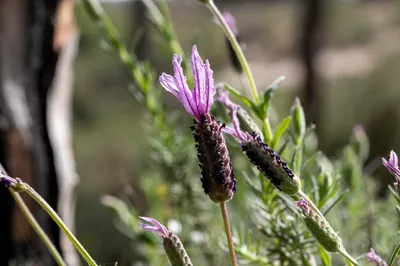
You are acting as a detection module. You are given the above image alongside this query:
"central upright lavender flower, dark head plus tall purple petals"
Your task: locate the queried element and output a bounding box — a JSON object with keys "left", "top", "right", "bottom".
{"left": 160, "top": 46, "right": 236, "bottom": 203}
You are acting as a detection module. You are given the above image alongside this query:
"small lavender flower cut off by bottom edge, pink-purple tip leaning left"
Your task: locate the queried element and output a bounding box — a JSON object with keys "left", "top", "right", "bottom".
{"left": 139, "top": 217, "right": 193, "bottom": 266}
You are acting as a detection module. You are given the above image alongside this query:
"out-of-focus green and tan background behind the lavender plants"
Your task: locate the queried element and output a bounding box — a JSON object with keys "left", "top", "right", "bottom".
{"left": 0, "top": 0, "right": 400, "bottom": 265}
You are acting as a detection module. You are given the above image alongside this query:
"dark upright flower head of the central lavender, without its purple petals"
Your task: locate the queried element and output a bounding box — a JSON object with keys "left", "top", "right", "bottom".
{"left": 191, "top": 114, "right": 236, "bottom": 203}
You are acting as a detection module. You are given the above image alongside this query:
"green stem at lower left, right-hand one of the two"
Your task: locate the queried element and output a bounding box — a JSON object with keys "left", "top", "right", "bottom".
{"left": 24, "top": 183, "right": 97, "bottom": 266}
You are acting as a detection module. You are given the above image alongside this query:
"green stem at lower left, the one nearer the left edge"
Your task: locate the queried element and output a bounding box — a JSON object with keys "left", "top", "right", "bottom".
{"left": 9, "top": 189, "right": 67, "bottom": 266}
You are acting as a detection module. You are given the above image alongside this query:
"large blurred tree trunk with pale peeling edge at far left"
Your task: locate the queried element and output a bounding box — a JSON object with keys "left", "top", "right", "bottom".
{"left": 0, "top": 0, "right": 77, "bottom": 265}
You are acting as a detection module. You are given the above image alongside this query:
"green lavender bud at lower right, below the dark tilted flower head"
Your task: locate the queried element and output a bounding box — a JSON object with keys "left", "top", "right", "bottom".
{"left": 296, "top": 198, "right": 343, "bottom": 252}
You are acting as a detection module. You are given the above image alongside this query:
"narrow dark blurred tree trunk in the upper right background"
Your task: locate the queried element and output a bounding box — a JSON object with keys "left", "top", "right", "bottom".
{"left": 299, "top": 0, "right": 326, "bottom": 124}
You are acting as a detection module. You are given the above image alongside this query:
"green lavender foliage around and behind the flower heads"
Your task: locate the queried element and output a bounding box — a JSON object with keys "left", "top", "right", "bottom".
{"left": 77, "top": 0, "right": 400, "bottom": 265}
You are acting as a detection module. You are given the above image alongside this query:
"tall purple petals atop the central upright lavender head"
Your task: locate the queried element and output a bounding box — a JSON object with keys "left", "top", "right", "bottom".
{"left": 160, "top": 45, "right": 215, "bottom": 121}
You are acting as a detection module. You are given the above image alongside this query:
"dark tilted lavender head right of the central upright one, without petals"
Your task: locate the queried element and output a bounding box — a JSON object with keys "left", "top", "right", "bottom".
{"left": 241, "top": 133, "right": 301, "bottom": 195}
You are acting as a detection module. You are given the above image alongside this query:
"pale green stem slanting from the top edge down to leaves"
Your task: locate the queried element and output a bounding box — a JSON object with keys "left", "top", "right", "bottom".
{"left": 207, "top": 0, "right": 260, "bottom": 104}
